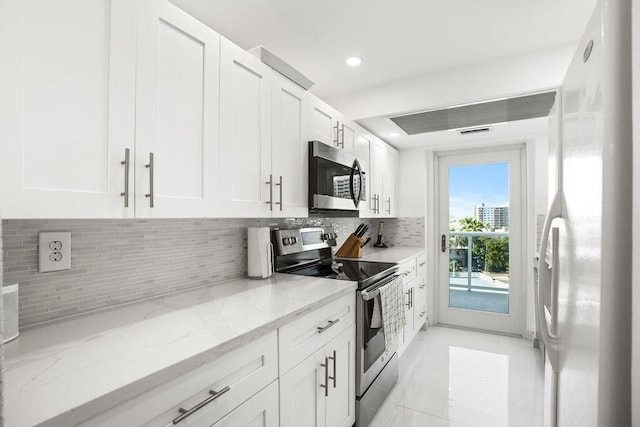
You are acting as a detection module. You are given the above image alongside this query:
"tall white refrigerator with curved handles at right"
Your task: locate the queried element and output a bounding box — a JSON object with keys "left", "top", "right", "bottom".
{"left": 536, "top": 0, "right": 635, "bottom": 427}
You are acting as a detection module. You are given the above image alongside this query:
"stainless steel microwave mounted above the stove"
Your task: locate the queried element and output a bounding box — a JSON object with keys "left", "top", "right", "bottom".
{"left": 309, "top": 141, "right": 367, "bottom": 216}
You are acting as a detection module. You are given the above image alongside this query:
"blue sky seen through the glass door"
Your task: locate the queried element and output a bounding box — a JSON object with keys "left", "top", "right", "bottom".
{"left": 449, "top": 163, "right": 509, "bottom": 219}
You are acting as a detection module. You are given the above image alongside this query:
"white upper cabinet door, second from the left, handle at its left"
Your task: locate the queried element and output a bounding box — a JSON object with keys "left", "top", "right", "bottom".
{"left": 135, "top": 0, "right": 220, "bottom": 217}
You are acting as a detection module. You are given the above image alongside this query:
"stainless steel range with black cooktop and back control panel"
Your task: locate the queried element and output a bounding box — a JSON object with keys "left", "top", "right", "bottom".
{"left": 272, "top": 227, "right": 402, "bottom": 426}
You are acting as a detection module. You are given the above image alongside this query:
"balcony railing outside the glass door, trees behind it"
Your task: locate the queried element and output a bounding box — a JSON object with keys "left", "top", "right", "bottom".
{"left": 449, "top": 231, "right": 509, "bottom": 293}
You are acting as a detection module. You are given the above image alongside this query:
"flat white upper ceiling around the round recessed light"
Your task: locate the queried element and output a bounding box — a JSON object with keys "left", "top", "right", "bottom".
{"left": 171, "top": 0, "right": 596, "bottom": 146}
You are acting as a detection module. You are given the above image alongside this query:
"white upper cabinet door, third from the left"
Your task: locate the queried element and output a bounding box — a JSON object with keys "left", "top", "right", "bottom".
{"left": 219, "top": 38, "right": 278, "bottom": 217}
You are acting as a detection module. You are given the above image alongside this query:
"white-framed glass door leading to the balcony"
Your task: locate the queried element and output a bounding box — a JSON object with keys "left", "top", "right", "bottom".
{"left": 438, "top": 149, "right": 525, "bottom": 334}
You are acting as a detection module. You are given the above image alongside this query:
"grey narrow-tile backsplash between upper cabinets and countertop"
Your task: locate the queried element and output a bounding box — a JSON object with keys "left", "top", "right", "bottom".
{"left": 0, "top": 218, "right": 424, "bottom": 327}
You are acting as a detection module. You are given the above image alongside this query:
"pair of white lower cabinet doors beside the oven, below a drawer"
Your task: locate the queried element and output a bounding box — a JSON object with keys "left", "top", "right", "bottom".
{"left": 280, "top": 324, "right": 355, "bottom": 427}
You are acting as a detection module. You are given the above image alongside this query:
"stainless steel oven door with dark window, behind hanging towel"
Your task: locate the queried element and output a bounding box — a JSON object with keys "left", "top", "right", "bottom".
{"left": 356, "top": 275, "right": 402, "bottom": 396}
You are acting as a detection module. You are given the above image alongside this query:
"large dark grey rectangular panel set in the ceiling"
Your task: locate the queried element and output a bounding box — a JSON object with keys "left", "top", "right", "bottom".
{"left": 389, "top": 91, "right": 556, "bottom": 135}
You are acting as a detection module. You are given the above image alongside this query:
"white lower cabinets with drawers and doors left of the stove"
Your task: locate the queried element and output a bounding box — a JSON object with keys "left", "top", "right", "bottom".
{"left": 80, "top": 294, "right": 356, "bottom": 427}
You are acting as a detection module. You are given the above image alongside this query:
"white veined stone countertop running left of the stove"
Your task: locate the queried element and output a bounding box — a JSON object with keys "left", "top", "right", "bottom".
{"left": 4, "top": 273, "right": 356, "bottom": 427}
